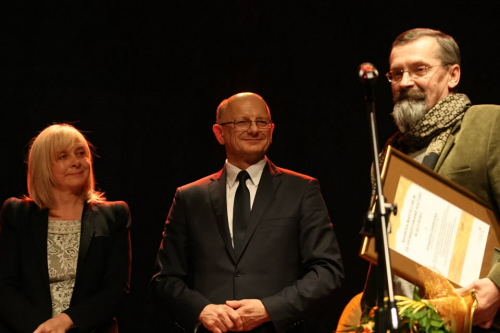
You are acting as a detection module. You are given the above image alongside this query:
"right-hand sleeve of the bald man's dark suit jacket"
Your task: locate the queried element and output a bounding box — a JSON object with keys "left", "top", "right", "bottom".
{"left": 262, "top": 179, "right": 344, "bottom": 332}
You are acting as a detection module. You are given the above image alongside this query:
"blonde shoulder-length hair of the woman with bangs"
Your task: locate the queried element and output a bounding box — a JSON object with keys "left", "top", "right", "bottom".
{"left": 27, "top": 123, "right": 106, "bottom": 209}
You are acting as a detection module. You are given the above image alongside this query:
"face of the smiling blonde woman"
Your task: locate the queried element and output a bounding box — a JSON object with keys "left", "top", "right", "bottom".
{"left": 52, "top": 140, "right": 90, "bottom": 192}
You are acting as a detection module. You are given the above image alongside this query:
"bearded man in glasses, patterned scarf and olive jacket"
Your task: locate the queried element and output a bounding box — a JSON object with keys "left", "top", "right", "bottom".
{"left": 339, "top": 28, "right": 500, "bottom": 329}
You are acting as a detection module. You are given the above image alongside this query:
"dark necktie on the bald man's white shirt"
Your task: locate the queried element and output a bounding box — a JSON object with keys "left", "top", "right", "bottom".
{"left": 233, "top": 170, "right": 250, "bottom": 256}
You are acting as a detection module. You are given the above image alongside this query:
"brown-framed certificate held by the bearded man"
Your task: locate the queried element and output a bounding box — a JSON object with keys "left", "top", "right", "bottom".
{"left": 360, "top": 147, "right": 500, "bottom": 287}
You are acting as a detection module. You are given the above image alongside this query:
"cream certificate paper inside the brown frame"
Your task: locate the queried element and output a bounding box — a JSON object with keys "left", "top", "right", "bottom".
{"left": 388, "top": 177, "right": 489, "bottom": 286}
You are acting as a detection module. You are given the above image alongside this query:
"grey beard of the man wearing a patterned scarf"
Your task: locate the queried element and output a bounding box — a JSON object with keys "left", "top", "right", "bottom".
{"left": 391, "top": 89, "right": 427, "bottom": 133}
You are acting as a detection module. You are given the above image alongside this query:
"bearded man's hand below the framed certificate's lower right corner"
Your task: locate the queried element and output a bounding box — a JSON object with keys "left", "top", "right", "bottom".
{"left": 456, "top": 278, "right": 500, "bottom": 328}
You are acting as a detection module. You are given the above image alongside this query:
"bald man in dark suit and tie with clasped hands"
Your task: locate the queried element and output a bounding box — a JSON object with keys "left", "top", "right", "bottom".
{"left": 150, "top": 93, "right": 344, "bottom": 332}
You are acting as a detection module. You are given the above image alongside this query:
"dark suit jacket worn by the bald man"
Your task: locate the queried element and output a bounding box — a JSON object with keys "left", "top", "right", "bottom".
{"left": 150, "top": 161, "right": 344, "bottom": 332}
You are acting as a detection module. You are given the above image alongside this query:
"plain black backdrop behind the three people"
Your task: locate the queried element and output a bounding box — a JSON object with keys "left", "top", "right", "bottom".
{"left": 0, "top": 0, "right": 500, "bottom": 332}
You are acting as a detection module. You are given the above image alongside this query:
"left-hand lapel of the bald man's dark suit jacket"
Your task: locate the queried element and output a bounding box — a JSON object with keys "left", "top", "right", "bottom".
{"left": 208, "top": 168, "right": 236, "bottom": 262}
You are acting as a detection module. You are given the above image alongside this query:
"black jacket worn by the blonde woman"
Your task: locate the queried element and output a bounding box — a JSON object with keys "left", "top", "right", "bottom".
{"left": 0, "top": 198, "right": 131, "bottom": 333}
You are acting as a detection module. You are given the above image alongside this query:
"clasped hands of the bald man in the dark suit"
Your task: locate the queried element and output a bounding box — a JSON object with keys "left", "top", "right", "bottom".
{"left": 199, "top": 299, "right": 271, "bottom": 333}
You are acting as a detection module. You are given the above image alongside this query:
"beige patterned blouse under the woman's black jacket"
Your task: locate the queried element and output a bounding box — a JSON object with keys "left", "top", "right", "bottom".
{"left": 47, "top": 220, "right": 81, "bottom": 317}
